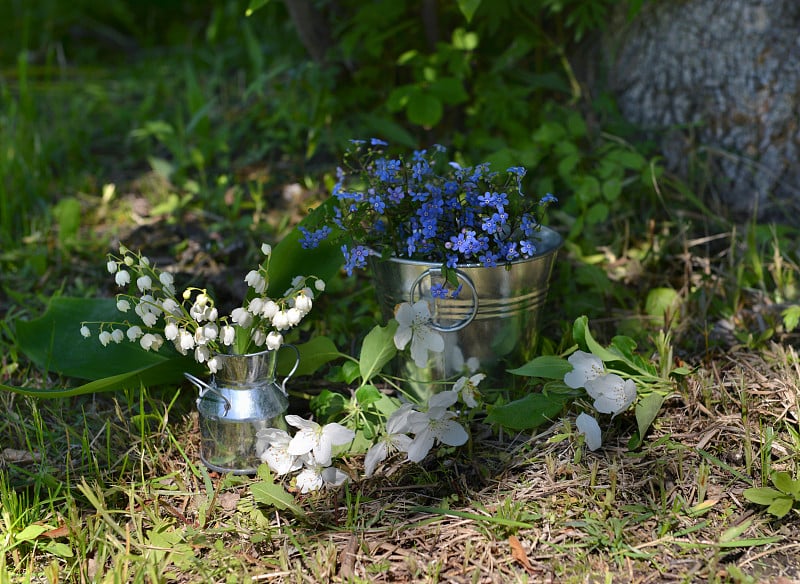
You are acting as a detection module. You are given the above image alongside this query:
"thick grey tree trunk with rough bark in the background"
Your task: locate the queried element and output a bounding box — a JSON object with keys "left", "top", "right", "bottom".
{"left": 606, "top": 0, "right": 800, "bottom": 223}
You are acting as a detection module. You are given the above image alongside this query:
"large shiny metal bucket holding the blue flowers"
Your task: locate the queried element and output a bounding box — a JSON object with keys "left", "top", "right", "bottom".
{"left": 370, "top": 227, "right": 563, "bottom": 398}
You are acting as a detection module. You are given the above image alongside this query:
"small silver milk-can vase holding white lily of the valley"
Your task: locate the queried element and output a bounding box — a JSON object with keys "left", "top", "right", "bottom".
{"left": 184, "top": 345, "right": 300, "bottom": 474}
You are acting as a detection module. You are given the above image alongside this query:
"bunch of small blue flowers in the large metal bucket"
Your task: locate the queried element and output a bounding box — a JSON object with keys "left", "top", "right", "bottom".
{"left": 300, "top": 139, "right": 556, "bottom": 275}
